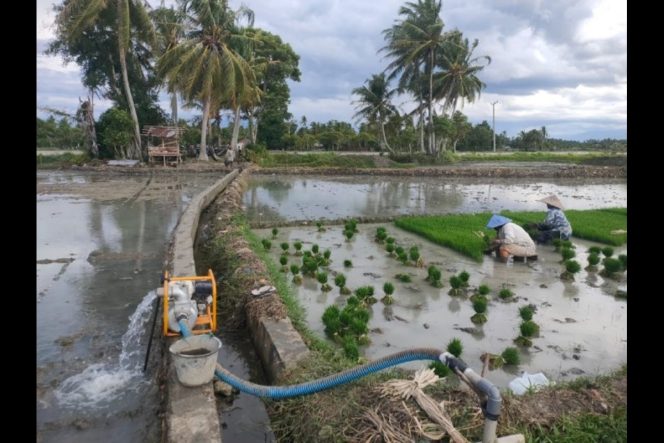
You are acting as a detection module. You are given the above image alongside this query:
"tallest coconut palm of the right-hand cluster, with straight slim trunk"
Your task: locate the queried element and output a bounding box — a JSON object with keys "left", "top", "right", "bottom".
{"left": 382, "top": 0, "right": 446, "bottom": 153}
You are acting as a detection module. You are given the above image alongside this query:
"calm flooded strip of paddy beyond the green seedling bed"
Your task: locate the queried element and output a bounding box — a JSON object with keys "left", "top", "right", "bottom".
{"left": 243, "top": 175, "right": 627, "bottom": 222}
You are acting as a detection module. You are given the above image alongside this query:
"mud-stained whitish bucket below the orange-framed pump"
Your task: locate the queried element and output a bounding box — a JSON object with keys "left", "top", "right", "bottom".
{"left": 168, "top": 334, "right": 221, "bottom": 386}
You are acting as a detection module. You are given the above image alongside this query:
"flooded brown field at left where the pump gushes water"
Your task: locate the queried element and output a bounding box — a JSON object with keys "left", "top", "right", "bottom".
{"left": 37, "top": 172, "right": 218, "bottom": 442}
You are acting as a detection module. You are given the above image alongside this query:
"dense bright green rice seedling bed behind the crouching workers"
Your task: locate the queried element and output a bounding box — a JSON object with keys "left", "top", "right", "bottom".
{"left": 394, "top": 208, "right": 627, "bottom": 261}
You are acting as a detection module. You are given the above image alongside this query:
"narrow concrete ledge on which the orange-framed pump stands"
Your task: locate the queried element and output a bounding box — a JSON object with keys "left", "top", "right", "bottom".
{"left": 166, "top": 169, "right": 239, "bottom": 443}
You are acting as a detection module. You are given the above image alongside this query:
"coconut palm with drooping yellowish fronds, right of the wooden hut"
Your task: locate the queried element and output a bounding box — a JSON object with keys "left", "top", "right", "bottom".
{"left": 157, "top": 0, "right": 253, "bottom": 161}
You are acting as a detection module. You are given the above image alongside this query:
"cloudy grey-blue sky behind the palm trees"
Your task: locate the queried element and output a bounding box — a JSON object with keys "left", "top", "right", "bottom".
{"left": 37, "top": 0, "right": 627, "bottom": 140}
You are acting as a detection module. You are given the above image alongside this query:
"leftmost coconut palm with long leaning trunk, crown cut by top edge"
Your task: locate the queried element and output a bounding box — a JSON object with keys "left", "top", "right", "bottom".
{"left": 55, "top": 0, "right": 154, "bottom": 158}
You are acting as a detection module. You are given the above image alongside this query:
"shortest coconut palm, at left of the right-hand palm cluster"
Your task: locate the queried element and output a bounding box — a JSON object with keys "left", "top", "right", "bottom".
{"left": 353, "top": 73, "right": 397, "bottom": 152}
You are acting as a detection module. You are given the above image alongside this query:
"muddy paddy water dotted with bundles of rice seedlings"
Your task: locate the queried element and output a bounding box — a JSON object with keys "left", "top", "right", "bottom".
{"left": 256, "top": 224, "right": 627, "bottom": 387}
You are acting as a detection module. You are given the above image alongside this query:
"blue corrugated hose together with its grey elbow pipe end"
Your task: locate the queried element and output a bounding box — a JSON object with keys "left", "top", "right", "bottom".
{"left": 178, "top": 322, "right": 502, "bottom": 443}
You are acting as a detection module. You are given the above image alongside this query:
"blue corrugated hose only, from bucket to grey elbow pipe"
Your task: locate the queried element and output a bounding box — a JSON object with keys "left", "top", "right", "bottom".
{"left": 178, "top": 321, "right": 443, "bottom": 400}
